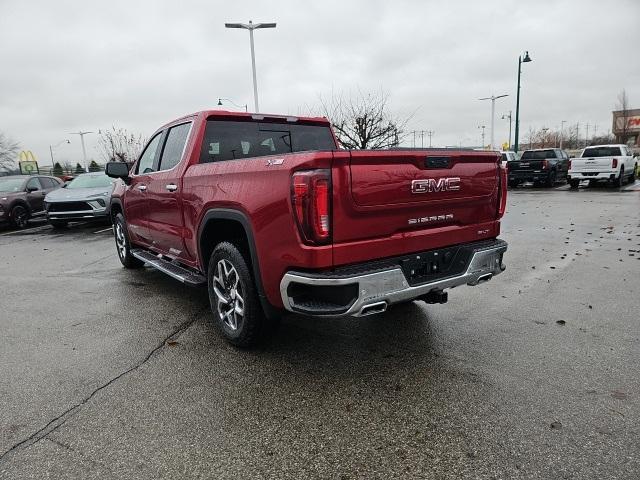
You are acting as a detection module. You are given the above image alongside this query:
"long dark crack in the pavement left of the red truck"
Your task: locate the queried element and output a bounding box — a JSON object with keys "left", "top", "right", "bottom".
{"left": 0, "top": 309, "right": 206, "bottom": 462}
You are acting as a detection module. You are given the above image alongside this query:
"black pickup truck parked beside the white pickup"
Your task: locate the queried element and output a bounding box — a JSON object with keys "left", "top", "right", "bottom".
{"left": 508, "top": 148, "right": 569, "bottom": 187}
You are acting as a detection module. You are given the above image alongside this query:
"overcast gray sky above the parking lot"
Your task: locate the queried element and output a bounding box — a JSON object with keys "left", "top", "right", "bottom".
{"left": 0, "top": 0, "right": 640, "bottom": 165}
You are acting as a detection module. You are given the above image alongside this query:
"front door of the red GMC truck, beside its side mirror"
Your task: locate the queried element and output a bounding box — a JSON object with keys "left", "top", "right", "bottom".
{"left": 124, "top": 132, "right": 163, "bottom": 245}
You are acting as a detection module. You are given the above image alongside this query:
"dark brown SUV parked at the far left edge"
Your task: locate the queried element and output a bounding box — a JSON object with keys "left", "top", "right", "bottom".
{"left": 0, "top": 175, "right": 62, "bottom": 228}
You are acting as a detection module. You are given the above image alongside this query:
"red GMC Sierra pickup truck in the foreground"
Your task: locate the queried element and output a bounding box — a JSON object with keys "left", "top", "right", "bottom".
{"left": 106, "top": 110, "right": 507, "bottom": 347}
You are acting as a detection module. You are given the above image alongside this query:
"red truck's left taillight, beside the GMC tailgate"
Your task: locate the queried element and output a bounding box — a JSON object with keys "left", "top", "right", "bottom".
{"left": 291, "top": 169, "right": 331, "bottom": 245}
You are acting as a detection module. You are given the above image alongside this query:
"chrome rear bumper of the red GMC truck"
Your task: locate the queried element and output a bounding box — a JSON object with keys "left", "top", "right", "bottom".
{"left": 280, "top": 240, "right": 507, "bottom": 317}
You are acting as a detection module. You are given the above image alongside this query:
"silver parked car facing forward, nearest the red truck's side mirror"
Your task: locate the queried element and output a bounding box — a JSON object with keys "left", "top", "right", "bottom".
{"left": 45, "top": 172, "right": 114, "bottom": 228}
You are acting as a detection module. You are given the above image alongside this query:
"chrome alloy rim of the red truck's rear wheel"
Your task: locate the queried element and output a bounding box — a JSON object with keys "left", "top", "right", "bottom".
{"left": 213, "top": 259, "right": 244, "bottom": 331}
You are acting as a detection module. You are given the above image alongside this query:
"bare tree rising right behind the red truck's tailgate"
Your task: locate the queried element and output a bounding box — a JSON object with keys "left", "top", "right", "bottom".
{"left": 320, "top": 90, "right": 410, "bottom": 150}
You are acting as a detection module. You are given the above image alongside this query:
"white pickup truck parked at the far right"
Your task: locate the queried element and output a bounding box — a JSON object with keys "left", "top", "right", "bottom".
{"left": 567, "top": 145, "right": 638, "bottom": 188}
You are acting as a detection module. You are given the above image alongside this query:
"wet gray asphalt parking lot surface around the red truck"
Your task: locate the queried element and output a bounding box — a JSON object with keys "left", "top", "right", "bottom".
{"left": 0, "top": 182, "right": 640, "bottom": 480}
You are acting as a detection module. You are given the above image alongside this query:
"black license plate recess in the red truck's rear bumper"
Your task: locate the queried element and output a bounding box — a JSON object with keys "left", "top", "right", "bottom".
{"left": 400, "top": 247, "right": 471, "bottom": 286}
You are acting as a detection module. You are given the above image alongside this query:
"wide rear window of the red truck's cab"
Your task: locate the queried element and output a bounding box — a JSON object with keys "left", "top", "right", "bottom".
{"left": 200, "top": 119, "right": 337, "bottom": 163}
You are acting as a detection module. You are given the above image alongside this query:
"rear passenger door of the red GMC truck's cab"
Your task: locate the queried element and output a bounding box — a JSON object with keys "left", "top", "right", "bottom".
{"left": 146, "top": 122, "right": 192, "bottom": 260}
